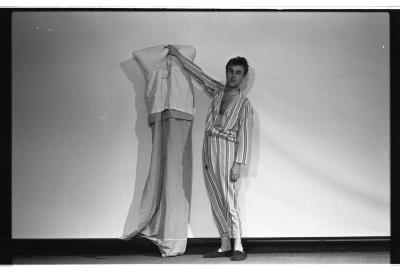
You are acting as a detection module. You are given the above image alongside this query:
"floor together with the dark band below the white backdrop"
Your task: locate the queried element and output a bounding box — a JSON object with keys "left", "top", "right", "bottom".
{"left": 8, "top": 239, "right": 391, "bottom": 265}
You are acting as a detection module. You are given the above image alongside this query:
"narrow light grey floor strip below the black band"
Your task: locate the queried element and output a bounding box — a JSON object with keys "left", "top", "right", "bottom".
{"left": 13, "top": 251, "right": 390, "bottom": 264}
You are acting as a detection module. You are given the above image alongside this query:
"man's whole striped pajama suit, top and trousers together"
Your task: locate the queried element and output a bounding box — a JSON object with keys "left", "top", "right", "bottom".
{"left": 183, "top": 53, "right": 253, "bottom": 238}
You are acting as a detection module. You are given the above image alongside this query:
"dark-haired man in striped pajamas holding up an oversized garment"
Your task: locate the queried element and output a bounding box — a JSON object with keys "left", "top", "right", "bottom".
{"left": 166, "top": 45, "right": 253, "bottom": 261}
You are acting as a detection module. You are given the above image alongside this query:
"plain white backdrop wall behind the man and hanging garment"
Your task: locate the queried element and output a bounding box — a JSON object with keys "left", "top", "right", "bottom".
{"left": 12, "top": 11, "right": 390, "bottom": 238}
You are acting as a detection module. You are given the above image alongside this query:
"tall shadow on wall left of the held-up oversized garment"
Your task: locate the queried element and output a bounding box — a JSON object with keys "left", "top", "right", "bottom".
{"left": 119, "top": 58, "right": 152, "bottom": 235}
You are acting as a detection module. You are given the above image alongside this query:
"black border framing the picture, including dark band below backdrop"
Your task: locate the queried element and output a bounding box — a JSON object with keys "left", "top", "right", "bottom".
{"left": 0, "top": 8, "right": 400, "bottom": 264}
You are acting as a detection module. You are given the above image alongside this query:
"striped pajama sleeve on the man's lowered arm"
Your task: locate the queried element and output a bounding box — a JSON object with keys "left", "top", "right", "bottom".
{"left": 235, "top": 99, "right": 253, "bottom": 164}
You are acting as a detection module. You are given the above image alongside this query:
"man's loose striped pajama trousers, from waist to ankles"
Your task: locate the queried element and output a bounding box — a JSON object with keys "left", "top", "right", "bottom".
{"left": 203, "top": 133, "right": 242, "bottom": 238}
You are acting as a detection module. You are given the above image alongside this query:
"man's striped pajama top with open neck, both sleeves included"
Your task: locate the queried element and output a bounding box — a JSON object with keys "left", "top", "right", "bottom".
{"left": 183, "top": 59, "right": 253, "bottom": 164}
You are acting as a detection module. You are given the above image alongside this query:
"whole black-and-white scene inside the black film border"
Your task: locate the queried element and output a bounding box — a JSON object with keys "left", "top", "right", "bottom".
{"left": 1, "top": 3, "right": 393, "bottom": 276}
